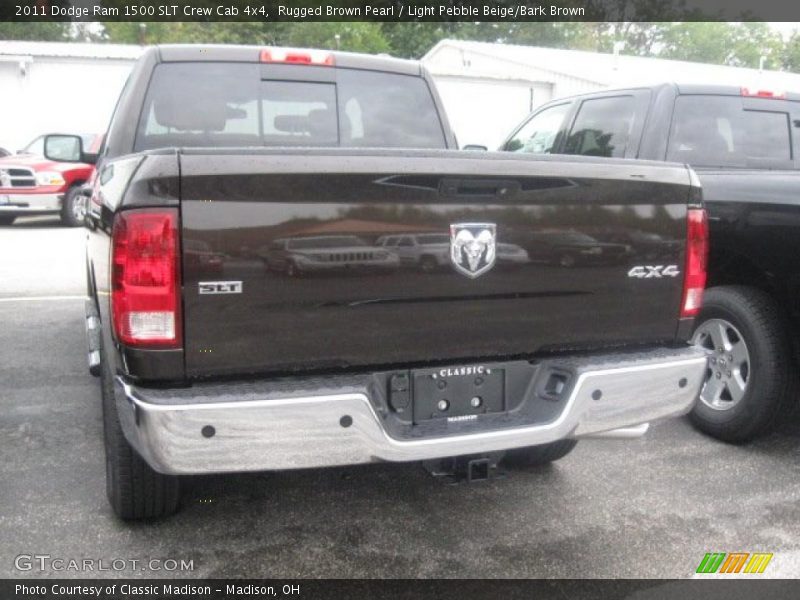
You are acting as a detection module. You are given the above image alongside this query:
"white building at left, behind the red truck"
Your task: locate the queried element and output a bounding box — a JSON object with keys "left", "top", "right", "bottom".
{"left": 0, "top": 42, "right": 142, "bottom": 151}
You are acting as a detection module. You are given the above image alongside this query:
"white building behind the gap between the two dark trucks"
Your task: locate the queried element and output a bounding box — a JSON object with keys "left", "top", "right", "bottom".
{"left": 422, "top": 40, "right": 800, "bottom": 149}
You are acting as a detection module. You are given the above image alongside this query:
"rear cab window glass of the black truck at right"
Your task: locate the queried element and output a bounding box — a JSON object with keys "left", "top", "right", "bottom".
{"left": 667, "top": 96, "right": 792, "bottom": 167}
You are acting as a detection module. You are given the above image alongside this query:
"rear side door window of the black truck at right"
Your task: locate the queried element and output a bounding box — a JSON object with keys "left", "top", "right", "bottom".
{"left": 564, "top": 96, "right": 636, "bottom": 158}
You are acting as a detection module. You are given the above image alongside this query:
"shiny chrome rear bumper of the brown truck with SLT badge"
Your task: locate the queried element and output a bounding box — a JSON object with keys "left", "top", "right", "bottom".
{"left": 115, "top": 347, "right": 706, "bottom": 474}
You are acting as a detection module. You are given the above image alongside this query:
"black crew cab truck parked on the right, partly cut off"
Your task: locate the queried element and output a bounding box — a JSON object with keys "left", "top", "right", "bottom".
{"left": 501, "top": 84, "right": 800, "bottom": 442}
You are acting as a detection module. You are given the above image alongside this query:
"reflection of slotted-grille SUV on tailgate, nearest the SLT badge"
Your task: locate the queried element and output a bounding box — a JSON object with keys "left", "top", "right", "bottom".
{"left": 259, "top": 235, "right": 400, "bottom": 277}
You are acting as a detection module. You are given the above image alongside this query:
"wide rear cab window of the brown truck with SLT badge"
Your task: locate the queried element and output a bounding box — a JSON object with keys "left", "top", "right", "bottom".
{"left": 135, "top": 62, "right": 445, "bottom": 151}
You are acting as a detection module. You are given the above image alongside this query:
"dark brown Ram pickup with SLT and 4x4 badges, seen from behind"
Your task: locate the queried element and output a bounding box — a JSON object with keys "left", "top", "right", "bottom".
{"left": 46, "top": 46, "right": 707, "bottom": 518}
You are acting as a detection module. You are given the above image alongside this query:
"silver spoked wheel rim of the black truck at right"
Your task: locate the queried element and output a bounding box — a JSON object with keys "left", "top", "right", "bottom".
{"left": 692, "top": 319, "right": 750, "bottom": 410}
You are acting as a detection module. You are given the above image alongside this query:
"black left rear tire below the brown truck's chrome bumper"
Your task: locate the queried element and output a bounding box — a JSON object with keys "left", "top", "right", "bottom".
{"left": 101, "top": 344, "right": 180, "bottom": 520}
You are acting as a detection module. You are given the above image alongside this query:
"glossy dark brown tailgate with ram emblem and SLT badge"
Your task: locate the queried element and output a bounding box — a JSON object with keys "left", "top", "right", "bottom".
{"left": 180, "top": 149, "right": 689, "bottom": 377}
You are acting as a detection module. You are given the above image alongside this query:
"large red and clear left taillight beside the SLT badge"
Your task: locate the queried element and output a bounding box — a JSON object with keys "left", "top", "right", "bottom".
{"left": 111, "top": 208, "right": 182, "bottom": 348}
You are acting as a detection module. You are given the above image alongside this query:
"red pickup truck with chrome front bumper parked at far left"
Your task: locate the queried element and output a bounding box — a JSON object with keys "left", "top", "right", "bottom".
{"left": 0, "top": 134, "right": 103, "bottom": 227}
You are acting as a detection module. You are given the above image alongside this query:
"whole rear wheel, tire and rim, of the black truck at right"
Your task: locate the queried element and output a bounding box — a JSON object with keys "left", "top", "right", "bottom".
{"left": 689, "top": 286, "right": 797, "bottom": 443}
